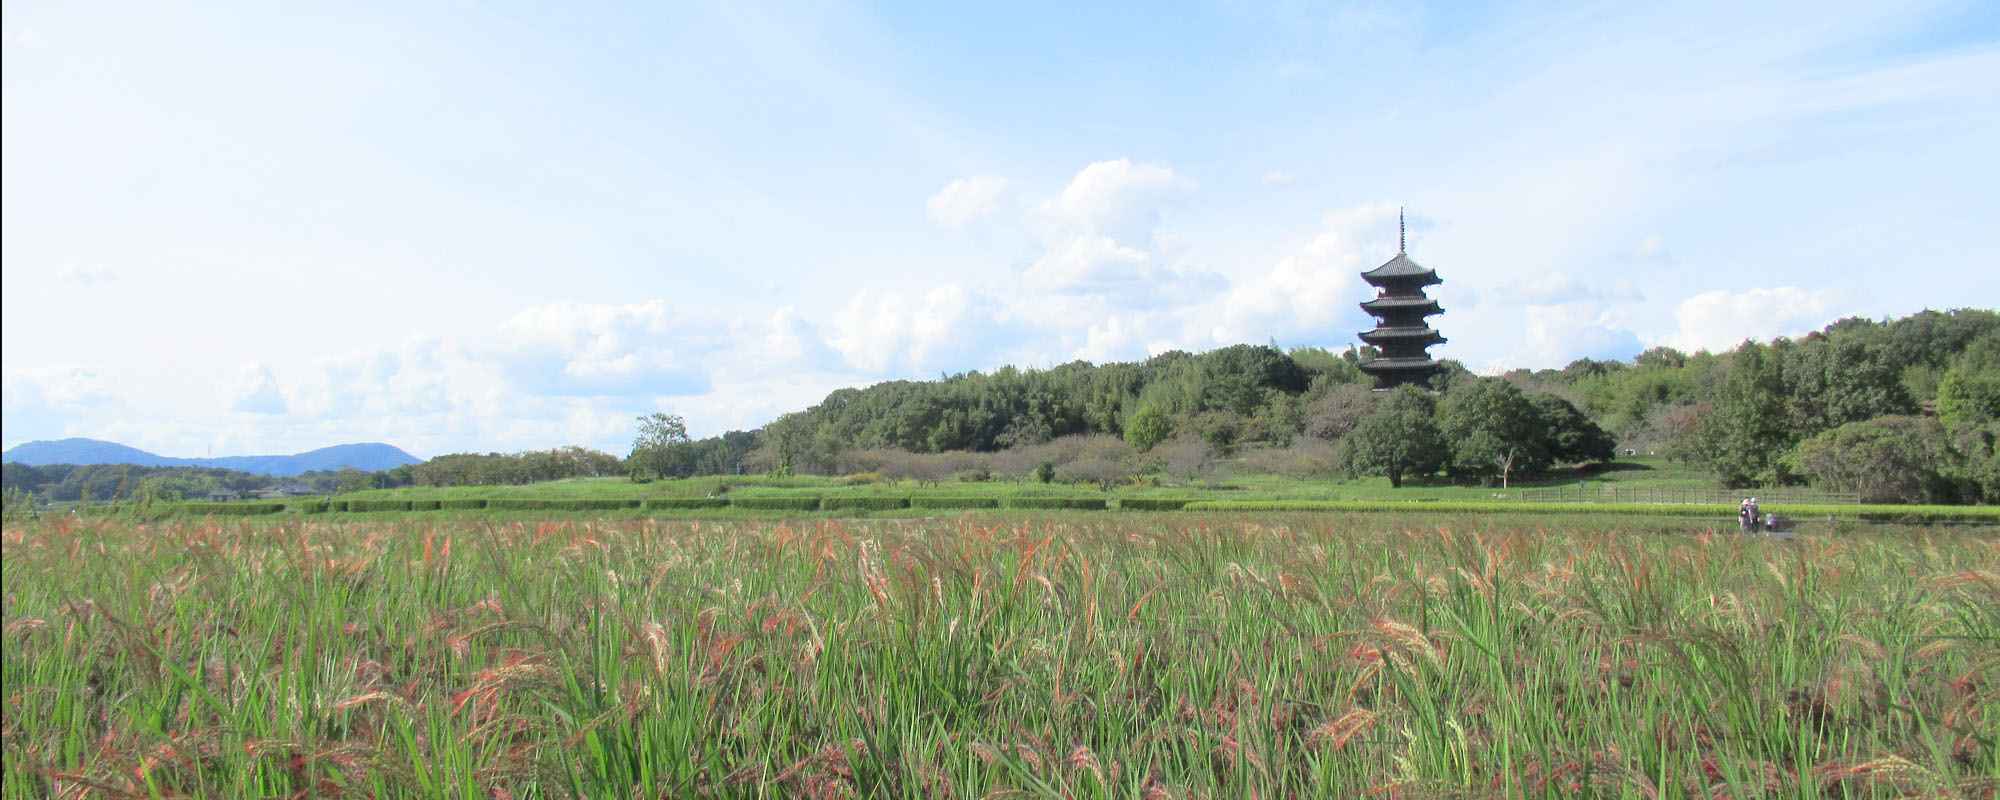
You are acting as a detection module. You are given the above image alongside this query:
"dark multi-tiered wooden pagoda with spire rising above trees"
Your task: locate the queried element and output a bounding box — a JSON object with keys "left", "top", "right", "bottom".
{"left": 1360, "top": 212, "right": 1444, "bottom": 392}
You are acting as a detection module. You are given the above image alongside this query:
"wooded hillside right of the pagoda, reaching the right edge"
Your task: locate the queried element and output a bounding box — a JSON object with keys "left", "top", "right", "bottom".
{"left": 1506, "top": 308, "right": 2000, "bottom": 502}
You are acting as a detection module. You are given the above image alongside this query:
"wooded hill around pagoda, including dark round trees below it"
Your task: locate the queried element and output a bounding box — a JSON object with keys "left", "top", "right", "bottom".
{"left": 720, "top": 308, "right": 2000, "bottom": 502}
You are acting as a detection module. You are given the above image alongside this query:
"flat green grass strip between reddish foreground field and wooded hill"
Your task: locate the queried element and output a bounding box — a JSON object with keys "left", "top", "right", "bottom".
{"left": 50, "top": 460, "right": 2000, "bottom": 526}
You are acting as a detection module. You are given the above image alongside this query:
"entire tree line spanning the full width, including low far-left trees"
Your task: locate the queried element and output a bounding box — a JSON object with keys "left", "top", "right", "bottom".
{"left": 4, "top": 310, "right": 2000, "bottom": 502}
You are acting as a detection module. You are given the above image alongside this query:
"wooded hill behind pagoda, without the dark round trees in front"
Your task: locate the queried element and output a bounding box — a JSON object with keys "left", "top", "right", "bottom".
{"left": 752, "top": 308, "right": 2000, "bottom": 496}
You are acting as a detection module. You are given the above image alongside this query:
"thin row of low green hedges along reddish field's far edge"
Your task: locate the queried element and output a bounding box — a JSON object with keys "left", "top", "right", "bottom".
{"left": 141, "top": 496, "right": 2000, "bottom": 522}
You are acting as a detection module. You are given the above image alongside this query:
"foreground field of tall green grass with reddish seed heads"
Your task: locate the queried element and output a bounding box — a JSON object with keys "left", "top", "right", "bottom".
{"left": 0, "top": 512, "right": 2000, "bottom": 798}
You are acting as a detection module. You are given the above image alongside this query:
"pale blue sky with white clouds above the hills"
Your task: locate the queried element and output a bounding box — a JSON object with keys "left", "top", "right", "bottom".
{"left": 0, "top": 2, "right": 2000, "bottom": 456}
